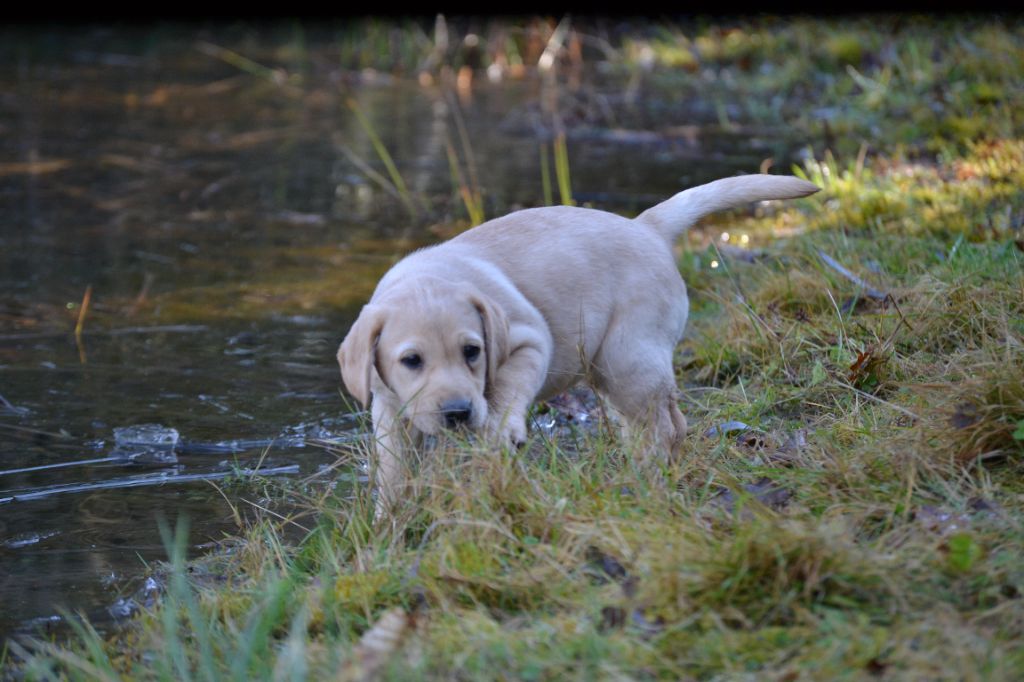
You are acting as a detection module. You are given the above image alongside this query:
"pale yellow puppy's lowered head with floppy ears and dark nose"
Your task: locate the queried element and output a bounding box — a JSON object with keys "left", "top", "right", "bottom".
{"left": 338, "top": 281, "right": 508, "bottom": 434}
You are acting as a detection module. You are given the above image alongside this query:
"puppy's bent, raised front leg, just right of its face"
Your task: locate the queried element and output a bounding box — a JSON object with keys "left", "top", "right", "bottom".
{"left": 485, "top": 333, "right": 550, "bottom": 447}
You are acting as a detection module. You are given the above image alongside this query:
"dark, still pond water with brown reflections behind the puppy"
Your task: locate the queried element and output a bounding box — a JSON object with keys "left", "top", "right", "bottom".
{"left": 0, "top": 21, "right": 797, "bottom": 637}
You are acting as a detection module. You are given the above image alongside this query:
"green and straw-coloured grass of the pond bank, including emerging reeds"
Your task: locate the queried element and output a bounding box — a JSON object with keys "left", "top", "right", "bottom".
{"left": 4, "top": 17, "right": 1024, "bottom": 680}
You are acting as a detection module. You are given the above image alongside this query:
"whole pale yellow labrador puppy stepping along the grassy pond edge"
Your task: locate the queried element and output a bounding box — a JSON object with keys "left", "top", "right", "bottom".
{"left": 338, "top": 175, "right": 818, "bottom": 515}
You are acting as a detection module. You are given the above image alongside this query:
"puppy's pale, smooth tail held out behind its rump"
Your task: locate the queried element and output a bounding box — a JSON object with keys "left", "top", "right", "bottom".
{"left": 636, "top": 174, "right": 820, "bottom": 244}
